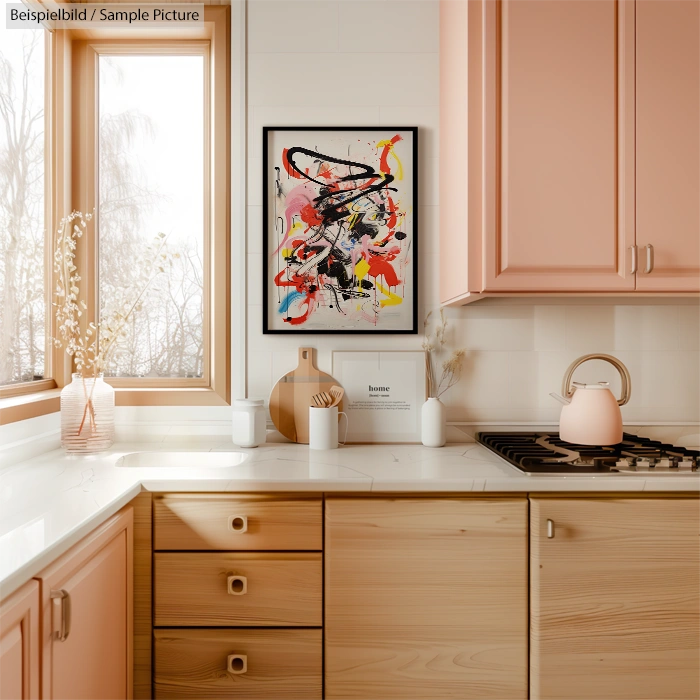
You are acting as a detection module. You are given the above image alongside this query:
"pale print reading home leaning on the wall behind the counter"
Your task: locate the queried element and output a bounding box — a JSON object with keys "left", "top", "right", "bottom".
{"left": 333, "top": 350, "right": 427, "bottom": 443}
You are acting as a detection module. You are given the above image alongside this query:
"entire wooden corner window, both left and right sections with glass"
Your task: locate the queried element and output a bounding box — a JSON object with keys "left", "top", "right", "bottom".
{"left": 0, "top": 6, "right": 230, "bottom": 424}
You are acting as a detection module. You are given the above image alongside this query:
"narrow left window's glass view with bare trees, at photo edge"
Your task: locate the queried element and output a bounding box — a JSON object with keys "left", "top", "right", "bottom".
{"left": 0, "top": 21, "right": 46, "bottom": 385}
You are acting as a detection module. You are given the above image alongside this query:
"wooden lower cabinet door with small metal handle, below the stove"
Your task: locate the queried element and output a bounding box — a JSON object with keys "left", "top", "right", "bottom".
{"left": 530, "top": 498, "right": 700, "bottom": 700}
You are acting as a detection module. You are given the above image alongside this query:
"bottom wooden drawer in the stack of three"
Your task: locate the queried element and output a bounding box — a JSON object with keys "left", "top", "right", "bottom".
{"left": 154, "top": 629, "right": 322, "bottom": 700}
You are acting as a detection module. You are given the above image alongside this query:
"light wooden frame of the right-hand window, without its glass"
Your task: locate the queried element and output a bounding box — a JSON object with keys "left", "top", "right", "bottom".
{"left": 71, "top": 7, "right": 230, "bottom": 406}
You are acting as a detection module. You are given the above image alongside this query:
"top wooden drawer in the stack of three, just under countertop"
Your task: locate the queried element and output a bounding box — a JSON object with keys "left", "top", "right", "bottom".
{"left": 153, "top": 494, "right": 323, "bottom": 552}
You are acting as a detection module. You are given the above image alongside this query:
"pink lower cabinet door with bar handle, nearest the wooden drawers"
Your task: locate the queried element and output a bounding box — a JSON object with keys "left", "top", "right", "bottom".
{"left": 41, "top": 506, "right": 133, "bottom": 700}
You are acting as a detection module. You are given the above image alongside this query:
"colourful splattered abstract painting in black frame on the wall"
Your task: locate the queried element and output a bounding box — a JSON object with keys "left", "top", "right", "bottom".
{"left": 263, "top": 127, "right": 418, "bottom": 333}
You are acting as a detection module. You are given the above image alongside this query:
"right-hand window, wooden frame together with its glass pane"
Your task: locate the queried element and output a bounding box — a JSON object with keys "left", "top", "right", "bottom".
{"left": 71, "top": 7, "right": 230, "bottom": 405}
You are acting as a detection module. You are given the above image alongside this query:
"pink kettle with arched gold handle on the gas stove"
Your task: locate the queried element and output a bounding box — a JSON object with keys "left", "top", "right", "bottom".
{"left": 550, "top": 355, "right": 632, "bottom": 445}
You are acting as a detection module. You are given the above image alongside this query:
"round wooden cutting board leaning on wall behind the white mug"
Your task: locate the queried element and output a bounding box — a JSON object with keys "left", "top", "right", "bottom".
{"left": 270, "top": 348, "right": 342, "bottom": 444}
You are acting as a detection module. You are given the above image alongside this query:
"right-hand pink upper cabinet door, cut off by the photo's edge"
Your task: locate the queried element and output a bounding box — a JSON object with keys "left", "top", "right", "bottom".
{"left": 636, "top": 0, "right": 700, "bottom": 292}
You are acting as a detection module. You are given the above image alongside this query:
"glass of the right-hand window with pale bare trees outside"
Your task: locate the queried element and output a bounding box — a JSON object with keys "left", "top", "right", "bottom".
{"left": 98, "top": 55, "right": 205, "bottom": 378}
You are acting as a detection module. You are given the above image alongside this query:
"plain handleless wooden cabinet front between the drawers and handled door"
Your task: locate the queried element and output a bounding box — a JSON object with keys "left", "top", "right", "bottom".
{"left": 325, "top": 498, "right": 527, "bottom": 700}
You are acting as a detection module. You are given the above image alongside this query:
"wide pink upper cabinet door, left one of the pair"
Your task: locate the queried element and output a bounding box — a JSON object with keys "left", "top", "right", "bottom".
{"left": 478, "top": 0, "right": 636, "bottom": 292}
